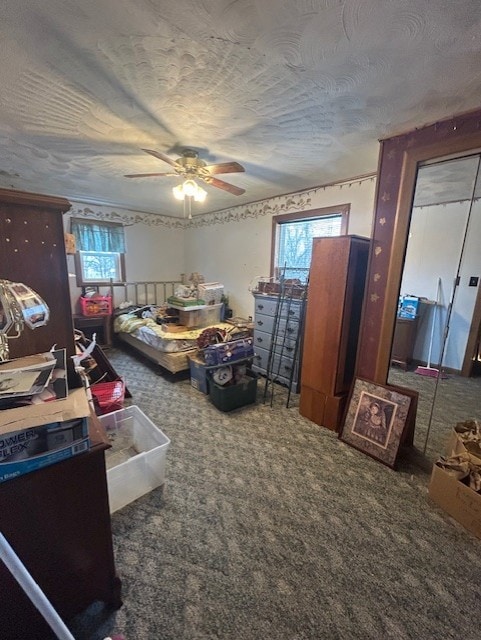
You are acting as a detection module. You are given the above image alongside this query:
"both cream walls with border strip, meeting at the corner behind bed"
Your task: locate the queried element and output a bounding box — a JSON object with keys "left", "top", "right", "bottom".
{"left": 64, "top": 178, "right": 375, "bottom": 317}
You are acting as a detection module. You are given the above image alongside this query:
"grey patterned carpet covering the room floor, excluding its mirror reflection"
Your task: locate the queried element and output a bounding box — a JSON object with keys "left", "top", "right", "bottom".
{"left": 72, "top": 350, "right": 481, "bottom": 640}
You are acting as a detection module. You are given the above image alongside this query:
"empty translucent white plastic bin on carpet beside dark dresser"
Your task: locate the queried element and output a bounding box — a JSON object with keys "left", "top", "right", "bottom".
{"left": 99, "top": 405, "right": 170, "bottom": 513}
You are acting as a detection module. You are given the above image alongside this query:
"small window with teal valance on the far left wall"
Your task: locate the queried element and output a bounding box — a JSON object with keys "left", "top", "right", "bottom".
{"left": 71, "top": 218, "right": 125, "bottom": 286}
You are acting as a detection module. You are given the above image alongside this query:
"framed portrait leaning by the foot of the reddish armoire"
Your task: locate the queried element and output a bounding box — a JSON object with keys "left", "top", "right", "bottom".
{"left": 339, "top": 378, "right": 414, "bottom": 469}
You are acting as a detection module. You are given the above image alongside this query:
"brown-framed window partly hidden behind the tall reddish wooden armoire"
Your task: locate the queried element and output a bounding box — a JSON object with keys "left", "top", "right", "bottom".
{"left": 271, "top": 204, "right": 349, "bottom": 283}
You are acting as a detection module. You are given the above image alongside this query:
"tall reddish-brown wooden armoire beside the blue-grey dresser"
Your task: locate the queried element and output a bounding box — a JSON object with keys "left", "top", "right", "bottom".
{"left": 299, "top": 235, "right": 369, "bottom": 431}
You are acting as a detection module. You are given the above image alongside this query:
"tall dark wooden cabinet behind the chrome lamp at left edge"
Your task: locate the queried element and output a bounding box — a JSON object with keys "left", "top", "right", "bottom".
{"left": 0, "top": 189, "right": 74, "bottom": 382}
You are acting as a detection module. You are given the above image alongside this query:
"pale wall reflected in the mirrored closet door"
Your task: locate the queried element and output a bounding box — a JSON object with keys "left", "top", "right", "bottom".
{"left": 401, "top": 202, "right": 481, "bottom": 370}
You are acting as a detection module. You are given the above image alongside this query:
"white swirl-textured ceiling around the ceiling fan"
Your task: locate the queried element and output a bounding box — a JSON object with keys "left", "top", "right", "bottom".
{"left": 0, "top": 0, "right": 481, "bottom": 216}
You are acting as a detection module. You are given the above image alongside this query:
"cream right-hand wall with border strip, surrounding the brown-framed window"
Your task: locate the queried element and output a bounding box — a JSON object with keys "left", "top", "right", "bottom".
{"left": 185, "top": 178, "right": 375, "bottom": 317}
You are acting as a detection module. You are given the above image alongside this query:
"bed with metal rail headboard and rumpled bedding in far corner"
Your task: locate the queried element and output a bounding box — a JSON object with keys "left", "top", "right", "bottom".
{"left": 111, "top": 282, "right": 233, "bottom": 374}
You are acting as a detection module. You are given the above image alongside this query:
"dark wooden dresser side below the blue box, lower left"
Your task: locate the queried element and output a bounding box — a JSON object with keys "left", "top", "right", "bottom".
{"left": 0, "top": 444, "right": 122, "bottom": 640}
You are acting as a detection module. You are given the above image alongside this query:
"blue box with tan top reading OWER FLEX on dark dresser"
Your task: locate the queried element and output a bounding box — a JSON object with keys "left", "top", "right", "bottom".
{"left": 0, "top": 389, "right": 90, "bottom": 482}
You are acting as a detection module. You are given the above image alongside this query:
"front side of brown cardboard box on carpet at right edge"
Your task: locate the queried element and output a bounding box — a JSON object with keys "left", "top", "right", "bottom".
{"left": 428, "top": 464, "right": 481, "bottom": 538}
